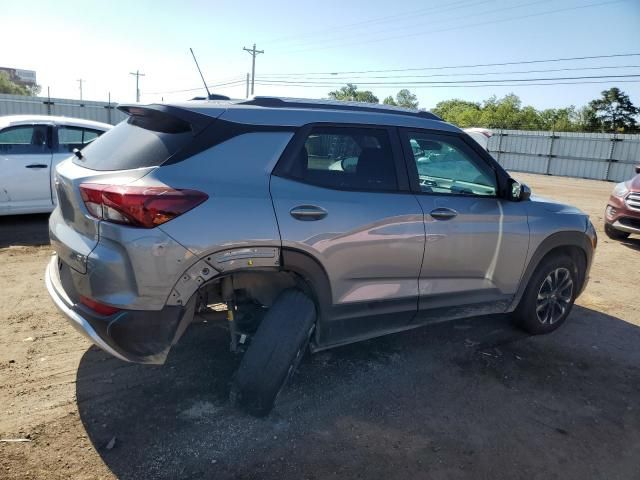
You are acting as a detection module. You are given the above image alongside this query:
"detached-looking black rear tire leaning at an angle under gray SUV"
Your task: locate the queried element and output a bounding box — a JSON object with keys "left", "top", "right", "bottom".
{"left": 230, "top": 289, "right": 316, "bottom": 417}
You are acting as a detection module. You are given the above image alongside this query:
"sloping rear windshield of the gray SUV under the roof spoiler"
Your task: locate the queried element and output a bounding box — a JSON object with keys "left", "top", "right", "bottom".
{"left": 73, "top": 116, "right": 193, "bottom": 171}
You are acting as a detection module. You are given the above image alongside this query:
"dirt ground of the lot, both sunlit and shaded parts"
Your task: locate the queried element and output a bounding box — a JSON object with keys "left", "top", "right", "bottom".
{"left": 0, "top": 174, "right": 640, "bottom": 480}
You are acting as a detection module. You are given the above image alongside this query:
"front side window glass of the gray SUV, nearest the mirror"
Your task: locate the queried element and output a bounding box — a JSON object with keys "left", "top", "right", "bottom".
{"left": 408, "top": 132, "right": 497, "bottom": 196}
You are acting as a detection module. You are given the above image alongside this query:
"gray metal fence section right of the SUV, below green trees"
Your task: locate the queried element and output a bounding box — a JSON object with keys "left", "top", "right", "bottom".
{"left": 488, "top": 130, "right": 640, "bottom": 182}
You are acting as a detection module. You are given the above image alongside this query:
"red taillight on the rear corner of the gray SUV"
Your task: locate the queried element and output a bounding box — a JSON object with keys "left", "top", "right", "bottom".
{"left": 80, "top": 183, "right": 209, "bottom": 228}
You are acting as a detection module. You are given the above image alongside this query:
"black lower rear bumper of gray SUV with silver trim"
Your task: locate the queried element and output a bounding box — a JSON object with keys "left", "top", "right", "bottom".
{"left": 45, "top": 255, "right": 195, "bottom": 364}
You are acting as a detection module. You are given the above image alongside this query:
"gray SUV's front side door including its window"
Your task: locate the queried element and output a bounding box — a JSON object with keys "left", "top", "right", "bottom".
{"left": 403, "top": 130, "right": 529, "bottom": 321}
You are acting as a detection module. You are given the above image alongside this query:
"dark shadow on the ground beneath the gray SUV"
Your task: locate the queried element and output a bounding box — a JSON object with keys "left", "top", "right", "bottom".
{"left": 77, "top": 307, "right": 640, "bottom": 479}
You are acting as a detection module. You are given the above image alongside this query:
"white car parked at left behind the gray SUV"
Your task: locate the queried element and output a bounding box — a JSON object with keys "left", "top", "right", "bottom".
{"left": 0, "top": 115, "right": 111, "bottom": 215}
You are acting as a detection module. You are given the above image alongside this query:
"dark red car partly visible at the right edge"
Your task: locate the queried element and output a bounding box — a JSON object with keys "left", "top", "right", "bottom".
{"left": 604, "top": 165, "right": 640, "bottom": 240}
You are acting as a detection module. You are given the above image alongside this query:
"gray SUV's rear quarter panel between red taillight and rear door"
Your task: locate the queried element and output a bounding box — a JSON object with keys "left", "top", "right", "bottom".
{"left": 149, "top": 132, "right": 293, "bottom": 257}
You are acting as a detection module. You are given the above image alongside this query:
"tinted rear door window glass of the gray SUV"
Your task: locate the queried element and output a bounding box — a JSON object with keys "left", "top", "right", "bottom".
{"left": 288, "top": 127, "right": 398, "bottom": 191}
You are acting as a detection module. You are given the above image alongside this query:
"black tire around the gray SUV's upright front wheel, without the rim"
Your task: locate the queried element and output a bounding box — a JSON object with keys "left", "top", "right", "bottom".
{"left": 513, "top": 254, "right": 582, "bottom": 335}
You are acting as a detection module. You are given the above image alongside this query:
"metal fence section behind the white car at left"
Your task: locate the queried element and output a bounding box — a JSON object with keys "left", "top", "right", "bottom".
{"left": 0, "top": 94, "right": 126, "bottom": 125}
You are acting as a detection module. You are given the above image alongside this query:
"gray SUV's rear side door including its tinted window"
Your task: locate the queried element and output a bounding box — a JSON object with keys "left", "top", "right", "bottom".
{"left": 271, "top": 125, "right": 425, "bottom": 344}
